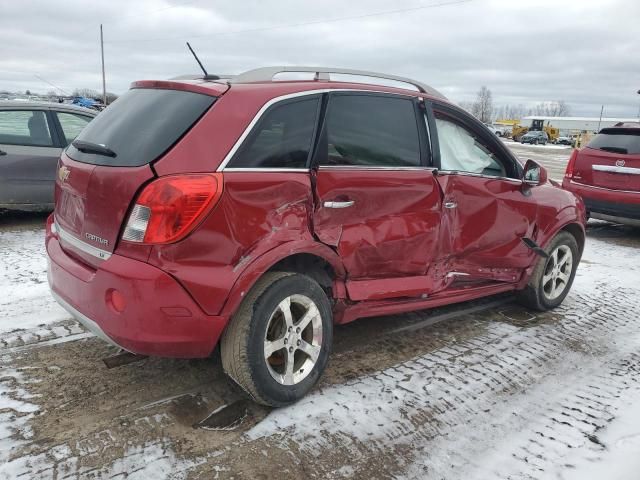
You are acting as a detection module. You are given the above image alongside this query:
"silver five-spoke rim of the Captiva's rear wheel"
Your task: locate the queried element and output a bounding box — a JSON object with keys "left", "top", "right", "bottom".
{"left": 264, "top": 294, "right": 322, "bottom": 385}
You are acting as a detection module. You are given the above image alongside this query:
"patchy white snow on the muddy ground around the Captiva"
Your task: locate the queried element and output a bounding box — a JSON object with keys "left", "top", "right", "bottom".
{"left": 0, "top": 213, "right": 640, "bottom": 480}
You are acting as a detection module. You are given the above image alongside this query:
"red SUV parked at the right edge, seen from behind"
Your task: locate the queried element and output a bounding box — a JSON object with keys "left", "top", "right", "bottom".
{"left": 562, "top": 122, "right": 640, "bottom": 226}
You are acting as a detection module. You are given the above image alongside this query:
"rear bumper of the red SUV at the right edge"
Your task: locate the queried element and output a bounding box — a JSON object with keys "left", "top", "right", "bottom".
{"left": 562, "top": 179, "right": 640, "bottom": 220}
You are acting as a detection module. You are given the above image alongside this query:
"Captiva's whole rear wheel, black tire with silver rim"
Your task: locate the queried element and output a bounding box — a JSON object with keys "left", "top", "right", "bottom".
{"left": 220, "top": 272, "right": 333, "bottom": 407}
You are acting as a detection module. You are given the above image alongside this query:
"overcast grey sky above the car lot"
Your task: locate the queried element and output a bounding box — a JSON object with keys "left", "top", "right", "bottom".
{"left": 0, "top": 0, "right": 640, "bottom": 117}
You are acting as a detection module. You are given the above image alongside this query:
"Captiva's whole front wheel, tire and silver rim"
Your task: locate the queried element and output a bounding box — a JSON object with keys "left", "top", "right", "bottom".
{"left": 518, "top": 232, "right": 580, "bottom": 311}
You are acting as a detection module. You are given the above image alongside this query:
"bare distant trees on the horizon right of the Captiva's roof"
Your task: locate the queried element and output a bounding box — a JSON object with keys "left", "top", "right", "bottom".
{"left": 459, "top": 86, "right": 571, "bottom": 123}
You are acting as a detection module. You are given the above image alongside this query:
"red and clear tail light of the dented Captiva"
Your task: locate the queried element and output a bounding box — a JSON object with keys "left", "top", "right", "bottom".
{"left": 122, "top": 173, "right": 223, "bottom": 244}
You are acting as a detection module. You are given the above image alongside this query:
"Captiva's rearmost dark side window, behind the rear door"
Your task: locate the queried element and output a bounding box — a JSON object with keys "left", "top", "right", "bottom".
{"left": 229, "top": 97, "right": 320, "bottom": 168}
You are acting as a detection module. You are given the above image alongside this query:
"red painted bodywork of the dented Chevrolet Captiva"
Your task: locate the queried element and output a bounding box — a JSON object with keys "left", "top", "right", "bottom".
{"left": 46, "top": 75, "right": 584, "bottom": 357}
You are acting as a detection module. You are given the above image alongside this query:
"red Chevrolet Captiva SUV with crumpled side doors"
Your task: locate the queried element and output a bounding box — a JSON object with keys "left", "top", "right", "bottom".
{"left": 46, "top": 67, "right": 585, "bottom": 406}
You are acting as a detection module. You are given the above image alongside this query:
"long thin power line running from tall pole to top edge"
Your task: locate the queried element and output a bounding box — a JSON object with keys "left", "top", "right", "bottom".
{"left": 105, "top": 0, "right": 473, "bottom": 44}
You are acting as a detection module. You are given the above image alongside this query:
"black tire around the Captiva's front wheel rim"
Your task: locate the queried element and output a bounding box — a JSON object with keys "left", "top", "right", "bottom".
{"left": 517, "top": 232, "right": 580, "bottom": 311}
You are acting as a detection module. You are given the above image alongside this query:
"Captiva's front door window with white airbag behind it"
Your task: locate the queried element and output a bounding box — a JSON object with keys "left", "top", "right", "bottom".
{"left": 436, "top": 114, "right": 506, "bottom": 177}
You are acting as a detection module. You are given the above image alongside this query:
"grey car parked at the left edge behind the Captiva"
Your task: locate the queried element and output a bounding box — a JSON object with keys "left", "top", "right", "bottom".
{"left": 0, "top": 101, "right": 97, "bottom": 211}
